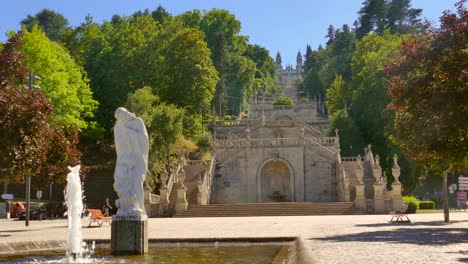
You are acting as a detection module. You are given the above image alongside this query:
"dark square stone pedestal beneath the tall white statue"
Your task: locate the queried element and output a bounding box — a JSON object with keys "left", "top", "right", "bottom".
{"left": 111, "top": 216, "right": 148, "bottom": 255}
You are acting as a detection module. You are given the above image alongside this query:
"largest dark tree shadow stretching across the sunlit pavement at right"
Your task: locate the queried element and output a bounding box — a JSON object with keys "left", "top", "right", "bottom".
{"left": 309, "top": 228, "right": 468, "bottom": 246}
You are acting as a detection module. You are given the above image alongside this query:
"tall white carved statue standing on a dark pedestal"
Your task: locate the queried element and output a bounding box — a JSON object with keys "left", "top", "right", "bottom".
{"left": 114, "top": 107, "right": 149, "bottom": 216}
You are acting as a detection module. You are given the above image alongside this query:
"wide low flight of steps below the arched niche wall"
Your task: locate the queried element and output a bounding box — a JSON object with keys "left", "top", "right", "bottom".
{"left": 176, "top": 202, "right": 366, "bottom": 217}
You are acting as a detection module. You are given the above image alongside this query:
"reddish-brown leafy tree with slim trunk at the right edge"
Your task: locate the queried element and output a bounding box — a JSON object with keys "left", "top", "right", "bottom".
{"left": 386, "top": 0, "right": 468, "bottom": 222}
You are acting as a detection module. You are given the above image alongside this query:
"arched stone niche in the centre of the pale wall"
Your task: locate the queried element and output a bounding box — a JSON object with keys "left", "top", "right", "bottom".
{"left": 258, "top": 159, "right": 294, "bottom": 202}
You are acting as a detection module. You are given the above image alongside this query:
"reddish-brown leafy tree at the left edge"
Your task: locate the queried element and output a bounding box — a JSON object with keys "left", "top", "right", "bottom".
{"left": 0, "top": 33, "right": 81, "bottom": 188}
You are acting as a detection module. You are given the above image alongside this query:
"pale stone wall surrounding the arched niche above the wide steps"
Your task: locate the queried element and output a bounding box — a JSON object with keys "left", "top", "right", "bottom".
{"left": 212, "top": 142, "right": 338, "bottom": 203}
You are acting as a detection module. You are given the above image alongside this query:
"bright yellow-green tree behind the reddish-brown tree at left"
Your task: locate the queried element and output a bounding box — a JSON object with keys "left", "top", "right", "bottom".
{"left": 20, "top": 27, "right": 97, "bottom": 130}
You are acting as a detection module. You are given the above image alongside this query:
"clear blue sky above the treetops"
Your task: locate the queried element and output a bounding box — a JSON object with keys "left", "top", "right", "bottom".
{"left": 0, "top": 0, "right": 457, "bottom": 64}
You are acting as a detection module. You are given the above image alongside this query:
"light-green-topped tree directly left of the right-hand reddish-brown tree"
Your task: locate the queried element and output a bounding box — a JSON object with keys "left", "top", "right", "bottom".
{"left": 350, "top": 30, "right": 405, "bottom": 153}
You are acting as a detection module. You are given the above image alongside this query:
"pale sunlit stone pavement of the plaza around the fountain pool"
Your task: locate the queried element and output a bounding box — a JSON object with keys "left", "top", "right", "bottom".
{"left": 0, "top": 212, "right": 468, "bottom": 264}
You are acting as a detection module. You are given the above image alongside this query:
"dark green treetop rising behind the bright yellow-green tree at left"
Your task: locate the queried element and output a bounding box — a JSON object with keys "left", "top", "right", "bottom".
{"left": 21, "top": 8, "right": 68, "bottom": 41}
